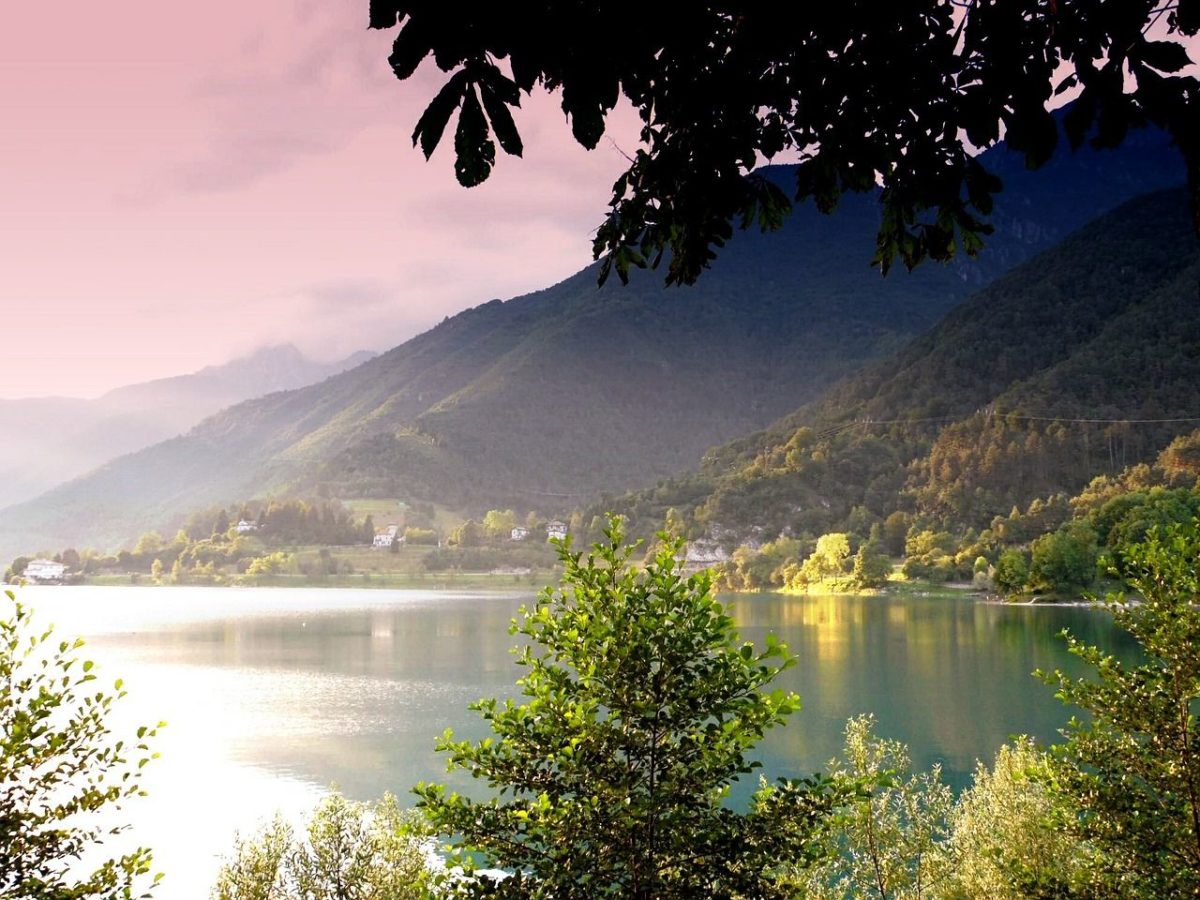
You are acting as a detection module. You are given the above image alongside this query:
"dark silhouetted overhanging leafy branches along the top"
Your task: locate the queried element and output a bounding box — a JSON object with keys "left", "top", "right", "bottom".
{"left": 370, "top": 0, "right": 1200, "bottom": 283}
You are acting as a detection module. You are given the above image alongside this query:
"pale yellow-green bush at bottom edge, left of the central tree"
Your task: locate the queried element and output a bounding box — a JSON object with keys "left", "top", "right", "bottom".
{"left": 211, "top": 792, "right": 428, "bottom": 900}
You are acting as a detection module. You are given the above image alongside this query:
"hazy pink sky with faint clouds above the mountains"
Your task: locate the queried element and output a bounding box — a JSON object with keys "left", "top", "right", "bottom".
{"left": 0, "top": 0, "right": 636, "bottom": 397}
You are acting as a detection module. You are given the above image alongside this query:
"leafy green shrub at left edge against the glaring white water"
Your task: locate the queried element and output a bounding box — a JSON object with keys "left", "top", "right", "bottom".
{"left": 0, "top": 592, "right": 157, "bottom": 900}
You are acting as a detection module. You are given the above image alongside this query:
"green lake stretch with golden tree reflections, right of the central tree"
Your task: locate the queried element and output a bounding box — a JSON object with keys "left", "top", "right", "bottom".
{"left": 728, "top": 594, "right": 1133, "bottom": 787}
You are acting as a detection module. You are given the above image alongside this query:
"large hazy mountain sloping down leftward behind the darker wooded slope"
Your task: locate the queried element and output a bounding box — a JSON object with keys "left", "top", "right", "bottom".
{"left": 0, "top": 127, "right": 1182, "bottom": 554}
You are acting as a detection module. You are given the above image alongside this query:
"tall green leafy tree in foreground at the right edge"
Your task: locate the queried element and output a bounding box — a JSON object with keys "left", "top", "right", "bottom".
{"left": 1046, "top": 522, "right": 1200, "bottom": 898}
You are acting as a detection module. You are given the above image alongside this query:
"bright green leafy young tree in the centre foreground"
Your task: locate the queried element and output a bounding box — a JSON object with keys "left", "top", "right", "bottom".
{"left": 416, "top": 520, "right": 833, "bottom": 900}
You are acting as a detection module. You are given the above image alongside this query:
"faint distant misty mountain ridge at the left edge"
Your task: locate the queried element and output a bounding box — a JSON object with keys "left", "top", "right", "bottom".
{"left": 0, "top": 346, "right": 374, "bottom": 506}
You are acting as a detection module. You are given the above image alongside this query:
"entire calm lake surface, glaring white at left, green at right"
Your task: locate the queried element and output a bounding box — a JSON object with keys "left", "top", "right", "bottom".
{"left": 11, "top": 587, "right": 1133, "bottom": 900}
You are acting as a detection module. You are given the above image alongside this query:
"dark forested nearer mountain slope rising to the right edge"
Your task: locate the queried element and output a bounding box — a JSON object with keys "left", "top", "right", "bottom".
{"left": 616, "top": 190, "right": 1200, "bottom": 542}
